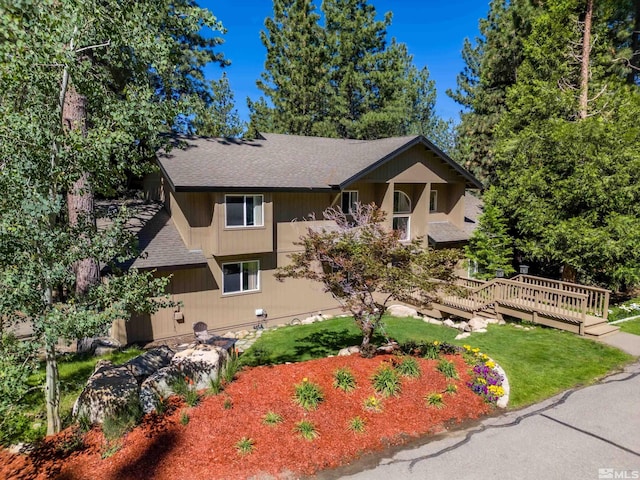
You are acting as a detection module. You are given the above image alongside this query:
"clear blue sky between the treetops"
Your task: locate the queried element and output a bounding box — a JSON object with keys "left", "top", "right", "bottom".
{"left": 199, "top": 0, "right": 489, "bottom": 121}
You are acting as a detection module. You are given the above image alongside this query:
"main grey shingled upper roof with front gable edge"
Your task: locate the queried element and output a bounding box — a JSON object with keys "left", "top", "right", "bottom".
{"left": 158, "top": 133, "right": 481, "bottom": 191}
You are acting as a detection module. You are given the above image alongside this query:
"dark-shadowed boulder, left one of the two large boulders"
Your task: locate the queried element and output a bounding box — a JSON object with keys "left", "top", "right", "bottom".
{"left": 73, "top": 360, "right": 139, "bottom": 423}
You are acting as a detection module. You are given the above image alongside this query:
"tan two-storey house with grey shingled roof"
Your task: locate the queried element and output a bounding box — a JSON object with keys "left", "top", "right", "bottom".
{"left": 113, "top": 134, "right": 481, "bottom": 342}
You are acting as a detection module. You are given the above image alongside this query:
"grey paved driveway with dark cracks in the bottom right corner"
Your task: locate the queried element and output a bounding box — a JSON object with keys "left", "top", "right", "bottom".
{"left": 316, "top": 334, "right": 640, "bottom": 480}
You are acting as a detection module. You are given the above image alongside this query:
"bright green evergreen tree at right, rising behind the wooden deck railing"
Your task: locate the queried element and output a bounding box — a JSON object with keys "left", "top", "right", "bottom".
{"left": 488, "top": 0, "right": 640, "bottom": 288}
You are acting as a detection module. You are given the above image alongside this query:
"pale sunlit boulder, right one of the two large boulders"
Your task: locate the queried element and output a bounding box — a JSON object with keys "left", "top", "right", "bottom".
{"left": 140, "top": 344, "right": 229, "bottom": 413}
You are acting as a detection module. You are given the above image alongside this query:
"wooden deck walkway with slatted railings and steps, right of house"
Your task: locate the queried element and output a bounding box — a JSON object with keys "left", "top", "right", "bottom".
{"left": 433, "top": 275, "right": 619, "bottom": 338}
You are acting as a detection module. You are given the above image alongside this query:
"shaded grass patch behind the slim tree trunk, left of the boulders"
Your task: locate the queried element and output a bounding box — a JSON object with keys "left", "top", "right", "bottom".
{"left": 25, "top": 348, "right": 143, "bottom": 439}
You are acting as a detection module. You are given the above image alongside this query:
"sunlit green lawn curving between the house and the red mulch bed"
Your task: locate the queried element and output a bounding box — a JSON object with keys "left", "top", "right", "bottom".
{"left": 243, "top": 317, "right": 632, "bottom": 407}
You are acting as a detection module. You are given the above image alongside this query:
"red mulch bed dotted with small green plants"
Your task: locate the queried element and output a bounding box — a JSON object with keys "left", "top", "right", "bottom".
{"left": 0, "top": 355, "right": 491, "bottom": 480}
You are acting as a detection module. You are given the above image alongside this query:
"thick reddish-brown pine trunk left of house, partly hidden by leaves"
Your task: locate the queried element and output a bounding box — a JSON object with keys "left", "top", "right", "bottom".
{"left": 62, "top": 87, "right": 100, "bottom": 295}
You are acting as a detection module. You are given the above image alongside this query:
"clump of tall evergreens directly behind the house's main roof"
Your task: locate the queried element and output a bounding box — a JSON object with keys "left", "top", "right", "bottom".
{"left": 249, "top": 0, "right": 451, "bottom": 142}
